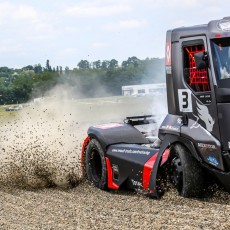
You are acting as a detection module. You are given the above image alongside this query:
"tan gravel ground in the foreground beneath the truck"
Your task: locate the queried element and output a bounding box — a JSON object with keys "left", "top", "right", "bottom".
{"left": 0, "top": 182, "right": 230, "bottom": 229}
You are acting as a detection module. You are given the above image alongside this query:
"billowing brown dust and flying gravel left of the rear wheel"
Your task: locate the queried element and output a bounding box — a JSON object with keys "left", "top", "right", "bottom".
{"left": 0, "top": 87, "right": 86, "bottom": 187}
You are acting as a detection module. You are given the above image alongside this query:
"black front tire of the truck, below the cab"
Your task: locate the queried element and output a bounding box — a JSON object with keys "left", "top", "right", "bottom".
{"left": 170, "top": 144, "right": 204, "bottom": 197}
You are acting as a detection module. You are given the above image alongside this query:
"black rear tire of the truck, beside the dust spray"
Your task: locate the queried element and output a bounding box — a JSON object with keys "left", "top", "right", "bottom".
{"left": 85, "top": 139, "right": 107, "bottom": 190}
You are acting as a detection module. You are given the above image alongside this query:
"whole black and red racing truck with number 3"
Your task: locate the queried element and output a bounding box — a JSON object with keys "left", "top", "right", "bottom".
{"left": 81, "top": 17, "right": 230, "bottom": 198}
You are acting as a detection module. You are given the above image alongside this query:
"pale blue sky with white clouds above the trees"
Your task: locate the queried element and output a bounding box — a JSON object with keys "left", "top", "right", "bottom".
{"left": 0, "top": 0, "right": 230, "bottom": 69}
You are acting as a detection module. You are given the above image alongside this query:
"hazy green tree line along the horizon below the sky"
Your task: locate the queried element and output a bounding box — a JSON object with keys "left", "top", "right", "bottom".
{"left": 0, "top": 57, "right": 165, "bottom": 105}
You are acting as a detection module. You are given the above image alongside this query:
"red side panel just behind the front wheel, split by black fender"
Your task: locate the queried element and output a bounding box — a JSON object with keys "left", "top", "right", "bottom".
{"left": 142, "top": 149, "right": 170, "bottom": 190}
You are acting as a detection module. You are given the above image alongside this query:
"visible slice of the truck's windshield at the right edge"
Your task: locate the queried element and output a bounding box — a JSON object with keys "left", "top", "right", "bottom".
{"left": 212, "top": 38, "right": 230, "bottom": 85}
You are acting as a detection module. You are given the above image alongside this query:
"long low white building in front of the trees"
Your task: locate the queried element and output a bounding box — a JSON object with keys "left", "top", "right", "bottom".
{"left": 121, "top": 83, "right": 166, "bottom": 96}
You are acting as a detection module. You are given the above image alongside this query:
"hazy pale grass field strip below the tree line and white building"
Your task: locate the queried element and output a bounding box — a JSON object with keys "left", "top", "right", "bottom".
{"left": 0, "top": 96, "right": 166, "bottom": 123}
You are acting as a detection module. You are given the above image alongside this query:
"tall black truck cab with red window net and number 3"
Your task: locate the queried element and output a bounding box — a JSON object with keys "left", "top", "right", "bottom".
{"left": 162, "top": 17, "right": 230, "bottom": 192}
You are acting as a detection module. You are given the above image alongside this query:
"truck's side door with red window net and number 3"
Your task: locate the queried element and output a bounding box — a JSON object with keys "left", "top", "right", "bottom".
{"left": 178, "top": 36, "right": 220, "bottom": 139}
